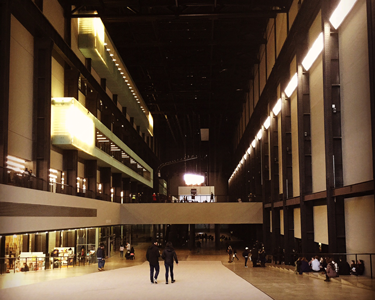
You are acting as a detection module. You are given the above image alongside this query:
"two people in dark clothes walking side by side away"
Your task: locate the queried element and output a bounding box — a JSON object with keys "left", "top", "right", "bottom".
{"left": 146, "top": 241, "right": 178, "bottom": 284}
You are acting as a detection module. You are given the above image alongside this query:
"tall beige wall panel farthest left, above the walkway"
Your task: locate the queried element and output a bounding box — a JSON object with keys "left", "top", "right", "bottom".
{"left": 8, "top": 15, "right": 34, "bottom": 161}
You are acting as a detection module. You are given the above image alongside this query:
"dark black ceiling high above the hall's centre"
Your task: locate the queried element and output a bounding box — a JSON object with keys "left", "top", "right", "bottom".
{"left": 64, "top": 0, "right": 291, "bottom": 175}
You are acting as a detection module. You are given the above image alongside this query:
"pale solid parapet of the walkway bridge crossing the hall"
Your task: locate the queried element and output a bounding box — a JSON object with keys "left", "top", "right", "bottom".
{"left": 0, "top": 184, "right": 263, "bottom": 234}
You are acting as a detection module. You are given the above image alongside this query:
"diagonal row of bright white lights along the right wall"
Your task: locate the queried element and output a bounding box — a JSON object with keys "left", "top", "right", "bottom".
{"left": 228, "top": 0, "right": 357, "bottom": 181}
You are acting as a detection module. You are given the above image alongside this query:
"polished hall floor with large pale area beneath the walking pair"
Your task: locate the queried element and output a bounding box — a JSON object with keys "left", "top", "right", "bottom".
{"left": 0, "top": 245, "right": 375, "bottom": 300}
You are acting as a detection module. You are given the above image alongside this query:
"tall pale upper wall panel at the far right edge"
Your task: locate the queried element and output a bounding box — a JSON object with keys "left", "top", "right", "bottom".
{"left": 339, "top": 0, "right": 374, "bottom": 185}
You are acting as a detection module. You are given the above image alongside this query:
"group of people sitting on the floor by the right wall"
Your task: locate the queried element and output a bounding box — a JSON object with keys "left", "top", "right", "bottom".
{"left": 295, "top": 256, "right": 365, "bottom": 281}
